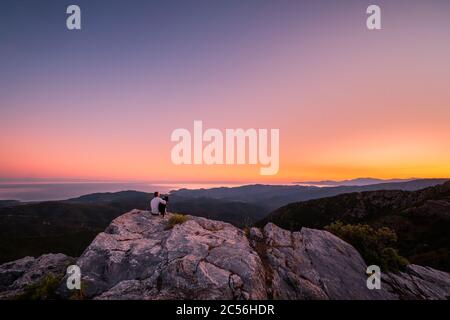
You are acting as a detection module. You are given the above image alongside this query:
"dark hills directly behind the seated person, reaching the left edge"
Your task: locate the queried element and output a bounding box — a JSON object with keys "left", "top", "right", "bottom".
{"left": 0, "top": 191, "right": 267, "bottom": 262}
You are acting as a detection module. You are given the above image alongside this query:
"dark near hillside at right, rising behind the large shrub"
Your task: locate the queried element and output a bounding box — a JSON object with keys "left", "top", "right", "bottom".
{"left": 256, "top": 181, "right": 450, "bottom": 271}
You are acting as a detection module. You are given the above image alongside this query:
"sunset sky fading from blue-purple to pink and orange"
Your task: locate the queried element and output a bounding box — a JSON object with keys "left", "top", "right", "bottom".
{"left": 0, "top": 0, "right": 450, "bottom": 182}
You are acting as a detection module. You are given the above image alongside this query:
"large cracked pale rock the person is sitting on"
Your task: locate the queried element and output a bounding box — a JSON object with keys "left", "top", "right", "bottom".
{"left": 65, "top": 210, "right": 266, "bottom": 299}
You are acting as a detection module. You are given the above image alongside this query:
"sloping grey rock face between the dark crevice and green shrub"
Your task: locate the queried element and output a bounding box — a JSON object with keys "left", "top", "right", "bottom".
{"left": 250, "top": 223, "right": 395, "bottom": 299}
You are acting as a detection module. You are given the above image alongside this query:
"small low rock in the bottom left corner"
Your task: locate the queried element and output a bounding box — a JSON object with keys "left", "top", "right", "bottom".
{"left": 0, "top": 254, "right": 75, "bottom": 299}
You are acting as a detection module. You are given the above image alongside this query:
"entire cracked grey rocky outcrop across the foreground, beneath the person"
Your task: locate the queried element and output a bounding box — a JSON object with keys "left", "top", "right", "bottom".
{"left": 0, "top": 210, "right": 450, "bottom": 299}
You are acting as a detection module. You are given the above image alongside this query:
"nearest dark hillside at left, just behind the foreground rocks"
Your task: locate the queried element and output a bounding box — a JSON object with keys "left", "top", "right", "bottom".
{"left": 0, "top": 202, "right": 123, "bottom": 262}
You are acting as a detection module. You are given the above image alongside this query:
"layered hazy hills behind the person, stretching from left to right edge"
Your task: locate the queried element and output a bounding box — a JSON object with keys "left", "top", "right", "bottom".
{"left": 0, "top": 179, "right": 445, "bottom": 262}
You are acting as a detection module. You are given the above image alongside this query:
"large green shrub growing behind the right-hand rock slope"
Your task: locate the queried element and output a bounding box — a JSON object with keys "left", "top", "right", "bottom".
{"left": 325, "top": 221, "right": 409, "bottom": 272}
